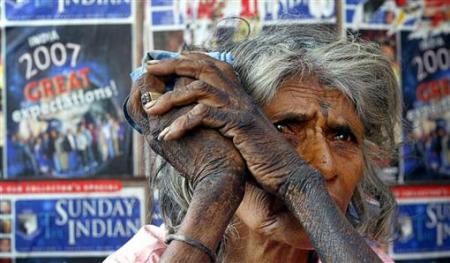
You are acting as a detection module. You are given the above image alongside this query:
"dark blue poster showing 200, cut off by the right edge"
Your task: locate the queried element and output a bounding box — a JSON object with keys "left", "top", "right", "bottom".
{"left": 400, "top": 28, "right": 450, "bottom": 182}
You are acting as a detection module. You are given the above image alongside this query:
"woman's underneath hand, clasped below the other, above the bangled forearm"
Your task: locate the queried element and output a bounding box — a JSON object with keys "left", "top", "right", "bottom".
{"left": 127, "top": 71, "right": 245, "bottom": 188}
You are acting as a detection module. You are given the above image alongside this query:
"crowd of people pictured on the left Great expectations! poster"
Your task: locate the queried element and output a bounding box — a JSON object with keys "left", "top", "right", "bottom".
{"left": 7, "top": 108, "right": 126, "bottom": 177}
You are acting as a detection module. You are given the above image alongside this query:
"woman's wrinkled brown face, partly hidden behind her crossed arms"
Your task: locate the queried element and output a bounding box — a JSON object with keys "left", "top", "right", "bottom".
{"left": 237, "top": 78, "right": 364, "bottom": 249}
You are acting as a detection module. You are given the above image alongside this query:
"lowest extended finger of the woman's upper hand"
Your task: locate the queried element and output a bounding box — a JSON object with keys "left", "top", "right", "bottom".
{"left": 158, "top": 104, "right": 234, "bottom": 141}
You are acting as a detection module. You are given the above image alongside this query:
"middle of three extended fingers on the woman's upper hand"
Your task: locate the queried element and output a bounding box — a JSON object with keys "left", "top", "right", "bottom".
{"left": 144, "top": 80, "right": 229, "bottom": 115}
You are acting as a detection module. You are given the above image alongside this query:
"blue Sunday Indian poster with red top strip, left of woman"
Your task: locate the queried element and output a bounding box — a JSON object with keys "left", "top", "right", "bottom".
{"left": 0, "top": 180, "right": 147, "bottom": 262}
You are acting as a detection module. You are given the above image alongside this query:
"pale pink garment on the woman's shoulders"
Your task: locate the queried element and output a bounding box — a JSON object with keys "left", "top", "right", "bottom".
{"left": 103, "top": 225, "right": 394, "bottom": 263}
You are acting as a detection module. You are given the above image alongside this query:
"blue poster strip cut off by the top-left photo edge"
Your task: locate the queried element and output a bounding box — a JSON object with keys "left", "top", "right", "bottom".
{"left": 3, "top": 0, "right": 132, "bottom": 21}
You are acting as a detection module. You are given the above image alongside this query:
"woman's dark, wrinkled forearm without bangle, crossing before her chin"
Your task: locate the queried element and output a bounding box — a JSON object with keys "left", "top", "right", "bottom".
{"left": 279, "top": 161, "right": 381, "bottom": 262}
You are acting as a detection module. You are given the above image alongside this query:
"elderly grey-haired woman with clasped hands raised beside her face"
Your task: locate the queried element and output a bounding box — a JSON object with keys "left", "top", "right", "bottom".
{"left": 109, "top": 26, "right": 399, "bottom": 262}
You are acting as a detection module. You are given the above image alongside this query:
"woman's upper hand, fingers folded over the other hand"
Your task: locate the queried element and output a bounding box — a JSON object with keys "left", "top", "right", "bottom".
{"left": 144, "top": 52, "right": 302, "bottom": 197}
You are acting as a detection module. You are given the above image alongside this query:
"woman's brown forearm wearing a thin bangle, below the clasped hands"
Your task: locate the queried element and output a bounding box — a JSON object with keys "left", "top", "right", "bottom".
{"left": 161, "top": 171, "right": 244, "bottom": 262}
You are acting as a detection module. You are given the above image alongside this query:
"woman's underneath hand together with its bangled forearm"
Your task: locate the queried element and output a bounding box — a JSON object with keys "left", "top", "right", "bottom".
{"left": 127, "top": 75, "right": 245, "bottom": 262}
